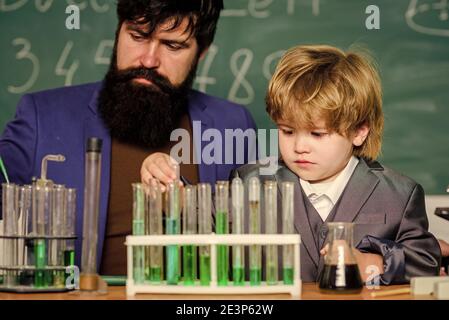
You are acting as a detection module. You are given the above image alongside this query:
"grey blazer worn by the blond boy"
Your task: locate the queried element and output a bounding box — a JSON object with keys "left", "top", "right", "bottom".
{"left": 231, "top": 159, "right": 441, "bottom": 284}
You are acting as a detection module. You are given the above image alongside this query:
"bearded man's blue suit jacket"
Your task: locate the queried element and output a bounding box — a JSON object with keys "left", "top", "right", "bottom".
{"left": 0, "top": 82, "right": 255, "bottom": 265}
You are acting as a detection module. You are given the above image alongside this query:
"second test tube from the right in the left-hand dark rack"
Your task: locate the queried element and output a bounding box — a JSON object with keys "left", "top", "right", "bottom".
{"left": 48, "top": 185, "right": 67, "bottom": 288}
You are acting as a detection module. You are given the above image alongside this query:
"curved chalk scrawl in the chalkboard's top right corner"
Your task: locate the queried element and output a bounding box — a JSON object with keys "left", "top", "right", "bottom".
{"left": 405, "top": 0, "right": 449, "bottom": 37}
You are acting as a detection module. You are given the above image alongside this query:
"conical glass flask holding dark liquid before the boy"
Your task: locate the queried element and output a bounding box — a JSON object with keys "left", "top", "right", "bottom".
{"left": 319, "top": 222, "right": 363, "bottom": 293}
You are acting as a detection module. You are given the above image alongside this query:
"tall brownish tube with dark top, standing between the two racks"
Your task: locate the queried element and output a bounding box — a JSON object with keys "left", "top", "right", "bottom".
{"left": 80, "top": 138, "right": 102, "bottom": 291}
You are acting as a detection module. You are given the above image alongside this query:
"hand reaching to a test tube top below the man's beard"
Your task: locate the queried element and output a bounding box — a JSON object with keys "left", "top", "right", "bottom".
{"left": 140, "top": 152, "right": 181, "bottom": 192}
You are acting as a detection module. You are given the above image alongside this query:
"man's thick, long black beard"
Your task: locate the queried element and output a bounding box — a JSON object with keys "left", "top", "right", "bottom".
{"left": 98, "top": 55, "right": 198, "bottom": 149}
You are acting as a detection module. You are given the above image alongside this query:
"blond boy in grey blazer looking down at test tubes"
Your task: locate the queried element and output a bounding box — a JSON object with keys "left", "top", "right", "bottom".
{"left": 235, "top": 46, "right": 441, "bottom": 284}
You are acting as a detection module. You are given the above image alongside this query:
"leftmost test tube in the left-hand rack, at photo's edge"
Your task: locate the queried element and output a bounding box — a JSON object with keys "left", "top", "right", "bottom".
{"left": 2, "top": 183, "right": 18, "bottom": 287}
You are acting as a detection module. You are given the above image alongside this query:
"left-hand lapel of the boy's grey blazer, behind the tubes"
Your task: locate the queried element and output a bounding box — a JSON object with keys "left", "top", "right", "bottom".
{"left": 275, "top": 164, "right": 320, "bottom": 266}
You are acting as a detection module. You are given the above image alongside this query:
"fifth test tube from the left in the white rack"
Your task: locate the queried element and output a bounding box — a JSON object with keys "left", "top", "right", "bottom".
{"left": 198, "top": 183, "right": 212, "bottom": 286}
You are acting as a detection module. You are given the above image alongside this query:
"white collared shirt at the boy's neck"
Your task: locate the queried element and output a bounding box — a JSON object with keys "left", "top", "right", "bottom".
{"left": 299, "top": 156, "right": 359, "bottom": 221}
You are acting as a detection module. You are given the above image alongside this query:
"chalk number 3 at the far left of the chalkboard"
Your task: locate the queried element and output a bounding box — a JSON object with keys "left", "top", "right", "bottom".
{"left": 8, "top": 38, "right": 40, "bottom": 94}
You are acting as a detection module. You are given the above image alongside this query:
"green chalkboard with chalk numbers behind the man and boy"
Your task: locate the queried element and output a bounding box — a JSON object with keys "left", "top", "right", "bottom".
{"left": 0, "top": 0, "right": 449, "bottom": 194}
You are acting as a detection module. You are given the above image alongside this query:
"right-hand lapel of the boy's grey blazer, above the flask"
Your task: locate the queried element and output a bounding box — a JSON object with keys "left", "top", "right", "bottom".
{"left": 333, "top": 158, "right": 379, "bottom": 222}
